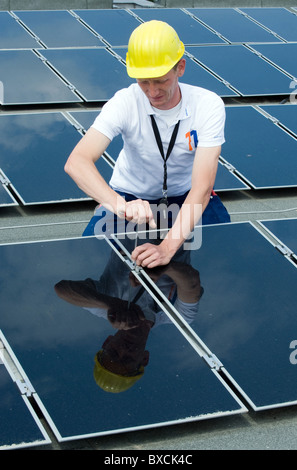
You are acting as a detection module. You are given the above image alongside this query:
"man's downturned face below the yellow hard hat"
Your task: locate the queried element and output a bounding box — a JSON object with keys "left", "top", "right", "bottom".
{"left": 137, "top": 59, "right": 185, "bottom": 109}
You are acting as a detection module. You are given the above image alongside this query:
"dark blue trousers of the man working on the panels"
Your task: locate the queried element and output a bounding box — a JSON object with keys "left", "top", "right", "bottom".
{"left": 82, "top": 192, "right": 230, "bottom": 237}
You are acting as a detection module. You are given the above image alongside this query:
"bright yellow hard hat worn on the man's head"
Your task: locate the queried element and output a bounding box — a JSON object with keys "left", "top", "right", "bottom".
{"left": 126, "top": 20, "right": 185, "bottom": 78}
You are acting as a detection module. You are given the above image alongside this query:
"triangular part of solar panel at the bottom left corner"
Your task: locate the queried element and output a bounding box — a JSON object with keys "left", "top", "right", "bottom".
{"left": 0, "top": 363, "right": 49, "bottom": 450}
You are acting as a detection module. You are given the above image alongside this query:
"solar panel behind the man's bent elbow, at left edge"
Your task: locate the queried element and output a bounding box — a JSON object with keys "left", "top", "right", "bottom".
{"left": 0, "top": 112, "right": 112, "bottom": 204}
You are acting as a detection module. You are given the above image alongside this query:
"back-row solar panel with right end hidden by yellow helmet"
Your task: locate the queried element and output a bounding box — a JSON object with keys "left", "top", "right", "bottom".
{"left": 74, "top": 9, "right": 140, "bottom": 46}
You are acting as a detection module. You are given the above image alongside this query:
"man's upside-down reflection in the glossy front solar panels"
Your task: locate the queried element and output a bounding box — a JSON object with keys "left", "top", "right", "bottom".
{"left": 55, "top": 246, "right": 203, "bottom": 393}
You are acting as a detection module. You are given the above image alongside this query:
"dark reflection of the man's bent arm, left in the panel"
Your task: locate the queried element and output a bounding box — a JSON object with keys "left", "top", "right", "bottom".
{"left": 55, "top": 279, "right": 110, "bottom": 309}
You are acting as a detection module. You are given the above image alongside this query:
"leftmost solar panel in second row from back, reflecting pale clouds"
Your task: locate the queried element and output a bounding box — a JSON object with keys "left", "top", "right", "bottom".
{"left": 0, "top": 50, "right": 81, "bottom": 105}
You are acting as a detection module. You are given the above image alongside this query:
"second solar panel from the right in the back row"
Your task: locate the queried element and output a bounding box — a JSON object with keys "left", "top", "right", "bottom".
{"left": 187, "top": 8, "right": 278, "bottom": 43}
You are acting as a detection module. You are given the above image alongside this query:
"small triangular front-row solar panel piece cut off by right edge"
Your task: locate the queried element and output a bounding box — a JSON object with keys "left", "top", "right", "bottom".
{"left": 262, "top": 219, "right": 297, "bottom": 255}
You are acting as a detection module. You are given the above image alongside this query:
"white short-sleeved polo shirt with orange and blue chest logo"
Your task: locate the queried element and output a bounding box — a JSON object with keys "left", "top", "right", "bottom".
{"left": 92, "top": 83, "right": 225, "bottom": 199}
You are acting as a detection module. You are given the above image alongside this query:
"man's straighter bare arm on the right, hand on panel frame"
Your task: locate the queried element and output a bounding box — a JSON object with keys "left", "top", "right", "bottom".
{"left": 132, "top": 146, "right": 221, "bottom": 268}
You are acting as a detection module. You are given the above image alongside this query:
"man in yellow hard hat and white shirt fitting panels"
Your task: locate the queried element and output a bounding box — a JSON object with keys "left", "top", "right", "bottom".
{"left": 65, "top": 20, "right": 229, "bottom": 268}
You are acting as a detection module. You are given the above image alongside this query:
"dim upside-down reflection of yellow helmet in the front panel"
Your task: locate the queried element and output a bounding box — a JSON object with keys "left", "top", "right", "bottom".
{"left": 94, "top": 351, "right": 144, "bottom": 393}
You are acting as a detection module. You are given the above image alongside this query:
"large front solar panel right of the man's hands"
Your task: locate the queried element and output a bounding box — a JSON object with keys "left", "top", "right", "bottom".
{"left": 124, "top": 223, "right": 297, "bottom": 410}
